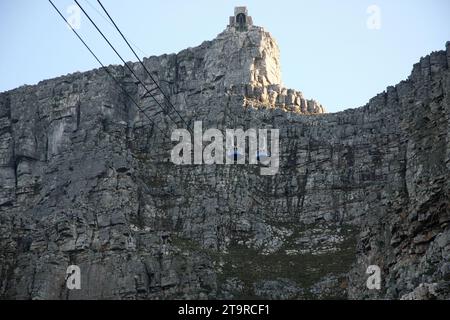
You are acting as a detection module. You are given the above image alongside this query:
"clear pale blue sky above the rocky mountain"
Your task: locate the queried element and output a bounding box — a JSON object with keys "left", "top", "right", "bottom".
{"left": 0, "top": 0, "right": 450, "bottom": 112}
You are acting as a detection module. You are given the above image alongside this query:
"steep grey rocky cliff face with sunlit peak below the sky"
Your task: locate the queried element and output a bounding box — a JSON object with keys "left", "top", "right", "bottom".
{"left": 0, "top": 21, "right": 450, "bottom": 299}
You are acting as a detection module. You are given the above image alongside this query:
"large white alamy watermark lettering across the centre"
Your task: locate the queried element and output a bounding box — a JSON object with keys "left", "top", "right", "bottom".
{"left": 171, "top": 121, "right": 280, "bottom": 176}
